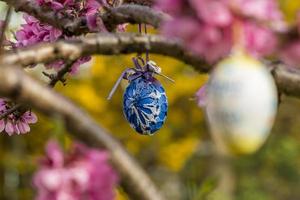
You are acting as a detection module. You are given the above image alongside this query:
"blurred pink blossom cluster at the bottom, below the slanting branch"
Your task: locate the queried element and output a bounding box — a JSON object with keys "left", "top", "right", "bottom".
{"left": 33, "top": 141, "right": 118, "bottom": 200}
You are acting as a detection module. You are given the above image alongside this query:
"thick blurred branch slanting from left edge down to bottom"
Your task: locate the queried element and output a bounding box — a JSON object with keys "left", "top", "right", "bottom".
{"left": 0, "top": 66, "right": 163, "bottom": 200}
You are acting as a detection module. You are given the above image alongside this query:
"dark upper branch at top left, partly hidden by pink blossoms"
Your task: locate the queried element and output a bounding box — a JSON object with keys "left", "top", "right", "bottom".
{"left": 2, "top": 0, "right": 164, "bottom": 35}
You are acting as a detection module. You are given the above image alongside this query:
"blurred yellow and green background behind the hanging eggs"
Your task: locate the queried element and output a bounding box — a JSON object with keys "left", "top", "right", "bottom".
{"left": 0, "top": 0, "right": 300, "bottom": 200}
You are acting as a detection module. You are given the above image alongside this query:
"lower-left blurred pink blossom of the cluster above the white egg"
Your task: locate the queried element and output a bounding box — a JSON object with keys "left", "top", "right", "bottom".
{"left": 162, "top": 17, "right": 232, "bottom": 63}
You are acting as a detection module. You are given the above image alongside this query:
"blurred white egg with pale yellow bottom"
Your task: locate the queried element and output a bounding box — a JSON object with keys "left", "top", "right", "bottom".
{"left": 206, "top": 52, "right": 277, "bottom": 154}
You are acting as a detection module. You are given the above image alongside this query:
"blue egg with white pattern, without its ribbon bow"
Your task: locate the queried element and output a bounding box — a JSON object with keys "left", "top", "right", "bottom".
{"left": 123, "top": 76, "right": 168, "bottom": 135}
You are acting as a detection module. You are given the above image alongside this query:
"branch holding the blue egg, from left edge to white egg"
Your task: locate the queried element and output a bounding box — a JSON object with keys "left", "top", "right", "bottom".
{"left": 2, "top": 33, "right": 210, "bottom": 72}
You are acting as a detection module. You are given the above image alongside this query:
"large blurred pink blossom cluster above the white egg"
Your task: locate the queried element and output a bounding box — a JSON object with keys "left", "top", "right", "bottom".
{"left": 157, "top": 0, "right": 285, "bottom": 63}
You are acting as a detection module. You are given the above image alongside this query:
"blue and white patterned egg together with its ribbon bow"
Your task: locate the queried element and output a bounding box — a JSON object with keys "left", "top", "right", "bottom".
{"left": 108, "top": 57, "right": 173, "bottom": 135}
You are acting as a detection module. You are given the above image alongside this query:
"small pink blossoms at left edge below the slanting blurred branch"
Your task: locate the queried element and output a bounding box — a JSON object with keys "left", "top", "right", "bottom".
{"left": 0, "top": 99, "right": 37, "bottom": 136}
